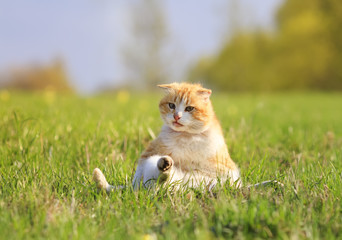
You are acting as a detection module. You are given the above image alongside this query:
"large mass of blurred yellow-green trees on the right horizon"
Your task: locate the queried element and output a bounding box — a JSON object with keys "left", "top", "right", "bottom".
{"left": 189, "top": 0, "right": 342, "bottom": 91}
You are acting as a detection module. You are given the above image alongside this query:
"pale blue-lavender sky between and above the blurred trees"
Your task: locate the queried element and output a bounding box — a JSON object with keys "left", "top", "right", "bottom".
{"left": 0, "top": 0, "right": 283, "bottom": 93}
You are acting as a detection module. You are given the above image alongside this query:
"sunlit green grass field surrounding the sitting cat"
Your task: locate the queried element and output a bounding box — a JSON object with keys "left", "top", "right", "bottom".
{"left": 0, "top": 93, "right": 342, "bottom": 239}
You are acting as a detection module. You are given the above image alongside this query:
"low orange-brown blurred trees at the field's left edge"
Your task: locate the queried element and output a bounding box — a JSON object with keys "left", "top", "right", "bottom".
{"left": 2, "top": 59, "right": 72, "bottom": 92}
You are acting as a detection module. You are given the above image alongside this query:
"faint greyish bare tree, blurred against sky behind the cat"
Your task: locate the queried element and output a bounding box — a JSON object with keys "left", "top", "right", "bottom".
{"left": 123, "top": 0, "right": 170, "bottom": 87}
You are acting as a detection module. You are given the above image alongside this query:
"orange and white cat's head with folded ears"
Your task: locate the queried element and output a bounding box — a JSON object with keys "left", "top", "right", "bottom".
{"left": 158, "top": 83, "right": 214, "bottom": 133}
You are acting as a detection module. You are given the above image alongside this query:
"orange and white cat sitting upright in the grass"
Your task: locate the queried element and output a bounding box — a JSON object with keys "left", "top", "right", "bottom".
{"left": 93, "top": 83, "right": 241, "bottom": 192}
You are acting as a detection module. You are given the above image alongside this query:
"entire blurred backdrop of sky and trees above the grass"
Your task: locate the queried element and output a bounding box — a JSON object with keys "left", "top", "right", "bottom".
{"left": 0, "top": 0, "right": 342, "bottom": 94}
